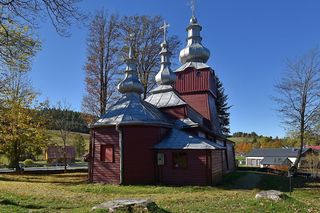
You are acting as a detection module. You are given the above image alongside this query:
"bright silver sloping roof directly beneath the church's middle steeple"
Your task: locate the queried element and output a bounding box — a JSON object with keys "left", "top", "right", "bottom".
{"left": 145, "top": 85, "right": 186, "bottom": 108}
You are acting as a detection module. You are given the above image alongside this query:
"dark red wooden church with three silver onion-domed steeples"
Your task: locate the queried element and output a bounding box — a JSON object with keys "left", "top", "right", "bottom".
{"left": 89, "top": 16, "right": 235, "bottom": 185}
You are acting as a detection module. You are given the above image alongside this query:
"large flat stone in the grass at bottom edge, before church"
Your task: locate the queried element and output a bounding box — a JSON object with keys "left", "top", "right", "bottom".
{"left": 92, "top": 199, "right": 158, "bottom": 212}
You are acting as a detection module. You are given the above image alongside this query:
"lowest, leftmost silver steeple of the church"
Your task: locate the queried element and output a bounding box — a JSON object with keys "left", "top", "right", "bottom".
{"left": 118, "top": 34, "right": 144, "bottom": 95}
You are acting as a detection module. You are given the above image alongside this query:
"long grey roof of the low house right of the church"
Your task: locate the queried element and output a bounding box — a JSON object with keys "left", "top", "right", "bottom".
{"left": 246, "top": 148, "right": 309, "bottom": 157}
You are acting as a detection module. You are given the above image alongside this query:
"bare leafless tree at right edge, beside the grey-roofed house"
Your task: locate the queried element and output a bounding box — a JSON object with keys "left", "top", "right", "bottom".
{"left": 275, "top": 49, "right": 320, "bottom": 171}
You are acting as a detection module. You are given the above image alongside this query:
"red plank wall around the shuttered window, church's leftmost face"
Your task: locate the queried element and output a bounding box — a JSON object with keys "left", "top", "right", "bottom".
{"left": 90, "top": 126, "right": 120, "bottom": 184}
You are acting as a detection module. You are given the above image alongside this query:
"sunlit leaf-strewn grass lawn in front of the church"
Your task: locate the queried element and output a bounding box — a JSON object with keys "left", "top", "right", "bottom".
{"left": 0, "top": 172, "right": 320, "bottom": 213}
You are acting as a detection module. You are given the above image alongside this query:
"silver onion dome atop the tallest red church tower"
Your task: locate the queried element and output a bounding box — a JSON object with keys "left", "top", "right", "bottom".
{"left": 179, "top": 16, "right": 210, "bottom": 64}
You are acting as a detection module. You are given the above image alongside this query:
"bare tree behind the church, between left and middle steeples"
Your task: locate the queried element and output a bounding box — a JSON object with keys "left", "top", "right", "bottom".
{"left": 121, "top": 16, "right": 181, "bottom": 99}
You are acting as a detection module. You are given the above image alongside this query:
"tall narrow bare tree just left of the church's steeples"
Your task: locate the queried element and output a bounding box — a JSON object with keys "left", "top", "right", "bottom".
{"left": 82, "top": 11, "right": 122, "bottom": 117}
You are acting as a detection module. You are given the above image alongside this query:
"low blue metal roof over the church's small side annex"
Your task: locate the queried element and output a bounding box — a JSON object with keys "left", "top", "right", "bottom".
{"left": 154, "top": 128, "right": 225, "bottom": 149}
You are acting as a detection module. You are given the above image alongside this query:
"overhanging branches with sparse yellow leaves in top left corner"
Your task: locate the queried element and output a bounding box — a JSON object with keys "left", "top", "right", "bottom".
{"left": 0, "top": 0, "right": 86, "bottom": 71}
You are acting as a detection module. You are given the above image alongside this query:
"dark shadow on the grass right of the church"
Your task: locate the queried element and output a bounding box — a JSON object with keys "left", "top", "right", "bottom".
{"left": 217, "top": 171, "right": 320, "bottom": 192}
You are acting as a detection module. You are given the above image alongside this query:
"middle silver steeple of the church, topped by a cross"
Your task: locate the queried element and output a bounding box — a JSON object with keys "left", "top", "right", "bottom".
{"left": 155, "top": 21, "right": 176, "bottom": 85}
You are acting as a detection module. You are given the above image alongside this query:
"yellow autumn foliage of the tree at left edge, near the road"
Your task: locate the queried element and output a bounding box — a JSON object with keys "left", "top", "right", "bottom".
{"left": 0, "top": 89, "right": 47, "bottom": 155}
